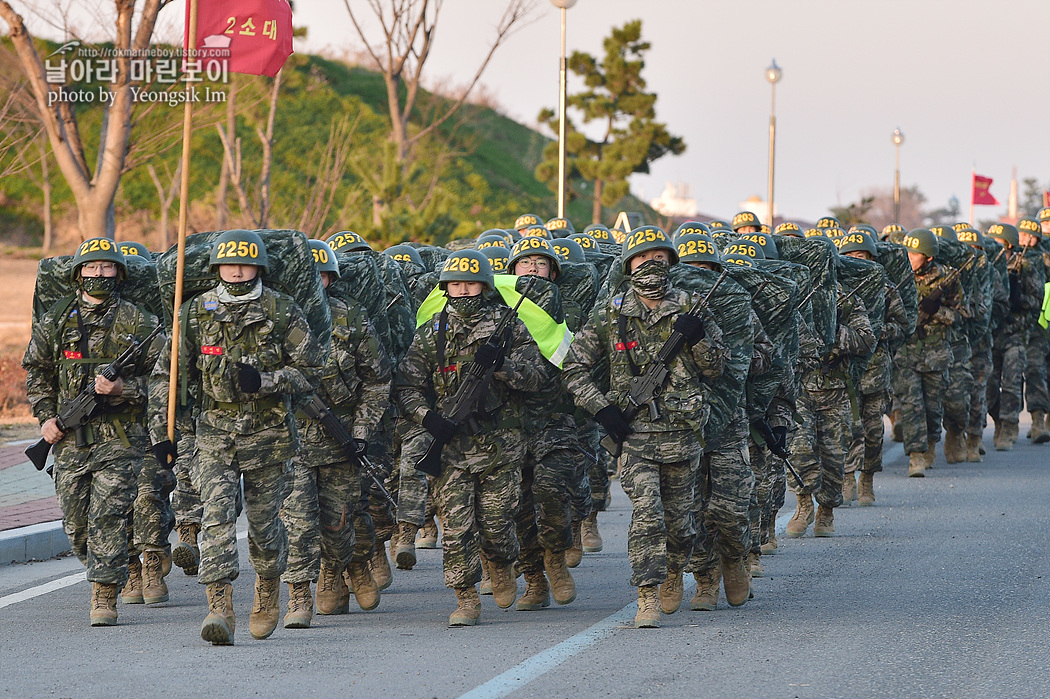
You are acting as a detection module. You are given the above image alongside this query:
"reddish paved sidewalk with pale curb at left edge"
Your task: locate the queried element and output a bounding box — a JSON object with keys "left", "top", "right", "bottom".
{"left": 0, "top": 441, "right": 69, "bottom": 566}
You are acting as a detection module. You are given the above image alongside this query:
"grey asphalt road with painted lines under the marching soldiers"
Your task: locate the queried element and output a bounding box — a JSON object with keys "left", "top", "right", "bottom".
{"left": 0, "top": 421, "right": 1050, "bottom": 698}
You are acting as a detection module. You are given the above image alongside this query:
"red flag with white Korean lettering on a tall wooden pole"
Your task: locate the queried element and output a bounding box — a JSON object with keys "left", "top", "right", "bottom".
{"left": 183, "top": 0, "right": 292, "bottom": 78}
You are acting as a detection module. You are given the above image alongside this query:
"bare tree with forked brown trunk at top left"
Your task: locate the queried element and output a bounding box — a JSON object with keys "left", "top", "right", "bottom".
{"left": 0, "top": 0, "right": 172, "bottom": 238}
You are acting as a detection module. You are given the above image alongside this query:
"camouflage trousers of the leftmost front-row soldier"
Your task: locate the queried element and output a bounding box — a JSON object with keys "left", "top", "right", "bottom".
{"left": 55, "top": 455, "right": 136, "bottom": 587}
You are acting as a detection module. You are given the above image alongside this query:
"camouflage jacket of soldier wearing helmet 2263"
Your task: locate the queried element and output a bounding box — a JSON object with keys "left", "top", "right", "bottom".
{"left": 394, "top": 295, "right": 553, "bottom": 472}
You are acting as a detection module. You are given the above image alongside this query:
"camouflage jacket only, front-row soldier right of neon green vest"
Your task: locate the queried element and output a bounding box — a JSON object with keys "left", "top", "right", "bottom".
{"left": 565, "top": 288, "right": 729, "bottom": 439}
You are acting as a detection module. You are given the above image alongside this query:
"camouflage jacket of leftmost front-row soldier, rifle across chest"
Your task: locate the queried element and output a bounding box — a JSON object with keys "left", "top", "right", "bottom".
{"left": 22, "top": 287, "right": 164, "bottom": 461}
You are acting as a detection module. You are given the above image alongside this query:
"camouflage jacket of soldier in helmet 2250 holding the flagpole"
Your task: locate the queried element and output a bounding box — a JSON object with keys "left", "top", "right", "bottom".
{"left": 149, "top": 285, "right": 323, "bottom": 447}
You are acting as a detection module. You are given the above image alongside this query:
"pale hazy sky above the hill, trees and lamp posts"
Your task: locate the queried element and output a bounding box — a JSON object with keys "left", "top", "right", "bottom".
{"left": 296, "top": 0, "right": 1050, "bottom": 220}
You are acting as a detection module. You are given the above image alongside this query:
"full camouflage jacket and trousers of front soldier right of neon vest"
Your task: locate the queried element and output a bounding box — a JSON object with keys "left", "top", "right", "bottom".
{"left": 564, "top": 287, "right": 729, "bottom": 587}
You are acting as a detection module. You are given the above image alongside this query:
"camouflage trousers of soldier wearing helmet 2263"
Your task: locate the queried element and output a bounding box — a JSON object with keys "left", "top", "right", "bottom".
{"left": 434, "top": 459, "right": 522, "bottom": 588}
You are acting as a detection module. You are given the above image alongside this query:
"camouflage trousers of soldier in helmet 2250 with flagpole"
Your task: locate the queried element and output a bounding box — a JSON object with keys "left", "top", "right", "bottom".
{"left": 196, "top": 425, "right": 292, "bottom": 585}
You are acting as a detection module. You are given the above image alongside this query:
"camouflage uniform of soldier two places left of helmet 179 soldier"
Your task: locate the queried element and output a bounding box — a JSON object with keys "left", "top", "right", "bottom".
{"left": 790, "top": 289, "right": 877, "bottom": 508}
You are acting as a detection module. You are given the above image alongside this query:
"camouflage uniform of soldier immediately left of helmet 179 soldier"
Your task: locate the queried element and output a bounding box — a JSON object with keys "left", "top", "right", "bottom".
{"left": 845, "top": 282, "right": 907, "bottom": 473}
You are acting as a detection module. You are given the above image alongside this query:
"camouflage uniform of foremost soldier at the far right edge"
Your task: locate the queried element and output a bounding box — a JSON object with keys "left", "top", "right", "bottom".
{"left": 987, "top": 251, "right": 1045, "bottom": 426}
